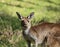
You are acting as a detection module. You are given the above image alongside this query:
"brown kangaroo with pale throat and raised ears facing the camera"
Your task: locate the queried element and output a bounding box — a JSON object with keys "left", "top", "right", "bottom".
{"left": 16, "top": 12, "right": 60, "bottom": 47}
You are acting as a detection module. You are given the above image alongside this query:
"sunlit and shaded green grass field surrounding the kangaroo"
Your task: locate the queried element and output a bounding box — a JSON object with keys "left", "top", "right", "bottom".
{"left": 0, "top": 0, "right": 60, "bottom": 47}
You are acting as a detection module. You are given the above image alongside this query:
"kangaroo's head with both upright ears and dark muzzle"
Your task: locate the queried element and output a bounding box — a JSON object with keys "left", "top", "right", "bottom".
{"left": 16, "top": 12, "right": 34, "bottom": 29}
